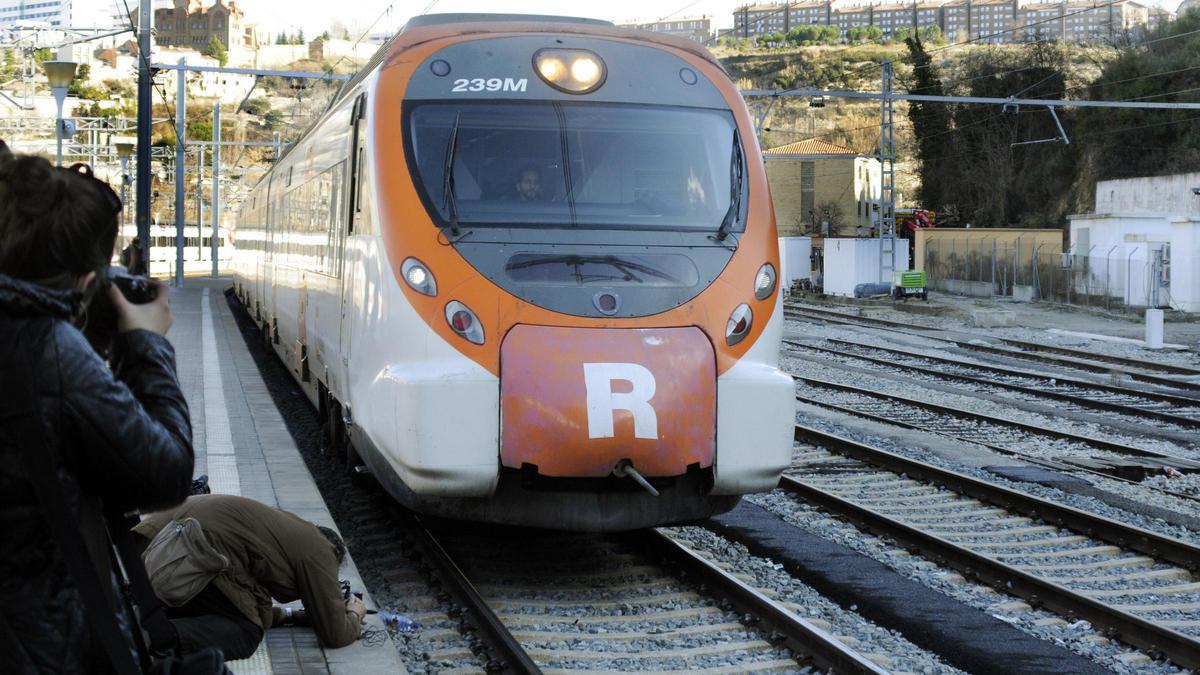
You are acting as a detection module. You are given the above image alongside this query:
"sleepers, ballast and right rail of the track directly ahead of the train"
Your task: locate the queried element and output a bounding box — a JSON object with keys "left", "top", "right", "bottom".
{"left": 417, "top": 525, "right": 882, "bottom": 673}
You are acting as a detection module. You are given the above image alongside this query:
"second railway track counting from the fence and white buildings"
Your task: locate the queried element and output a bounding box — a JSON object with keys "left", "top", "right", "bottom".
{"left": 784, "top": 339, "right": 1200, "bottom": 429}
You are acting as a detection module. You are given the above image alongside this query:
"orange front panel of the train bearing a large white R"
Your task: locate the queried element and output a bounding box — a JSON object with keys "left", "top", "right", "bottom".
{"left": 500, "top": 325, "right": 716, "bottom": 478}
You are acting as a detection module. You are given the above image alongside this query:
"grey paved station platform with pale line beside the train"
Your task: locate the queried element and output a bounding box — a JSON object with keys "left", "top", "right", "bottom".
{"left": 167, "top": 279, "right": 404, "bottom": 675}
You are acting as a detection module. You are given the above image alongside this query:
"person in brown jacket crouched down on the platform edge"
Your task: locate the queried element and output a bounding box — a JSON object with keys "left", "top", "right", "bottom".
{"left": 133, "top": 487, "right": 366, "bottom": 659}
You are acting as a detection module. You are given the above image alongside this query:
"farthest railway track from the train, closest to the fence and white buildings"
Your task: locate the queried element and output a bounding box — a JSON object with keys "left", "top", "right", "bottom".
{"left": 784, "top": 305, "right": 1200, "bottom": 393}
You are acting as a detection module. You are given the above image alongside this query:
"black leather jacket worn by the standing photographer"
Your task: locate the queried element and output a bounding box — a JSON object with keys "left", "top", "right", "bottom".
{"left": 0, "top": 275, "right": 193, "bottom": 673}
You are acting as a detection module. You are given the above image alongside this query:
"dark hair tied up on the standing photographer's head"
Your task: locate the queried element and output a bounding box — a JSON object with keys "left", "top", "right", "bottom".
{"left": 0, "top": 141, "right": 121, "bottom": 289}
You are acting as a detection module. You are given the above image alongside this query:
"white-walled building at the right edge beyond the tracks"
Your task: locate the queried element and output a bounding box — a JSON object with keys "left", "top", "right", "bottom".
{"left": 1068, "top": 173, "right": 1200, "bottom": 312}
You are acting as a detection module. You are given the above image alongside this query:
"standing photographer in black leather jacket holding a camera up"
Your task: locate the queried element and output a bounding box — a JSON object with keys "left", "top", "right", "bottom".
{"left": 0, "top": 142, "right": 192, "bottom": 673}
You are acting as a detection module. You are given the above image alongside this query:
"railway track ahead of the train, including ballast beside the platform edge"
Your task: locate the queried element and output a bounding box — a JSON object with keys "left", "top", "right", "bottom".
{"left": 319, "top": 444, "right": 886, "bottom": 674}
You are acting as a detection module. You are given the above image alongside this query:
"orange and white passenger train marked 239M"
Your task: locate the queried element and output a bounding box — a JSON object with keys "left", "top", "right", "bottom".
{"left": 230, "top": 9, "right": 796, "bottom": 531}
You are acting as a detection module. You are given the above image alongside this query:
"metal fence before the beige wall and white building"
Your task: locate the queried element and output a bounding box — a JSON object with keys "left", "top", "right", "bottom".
{"left": 925, "top": 238, "right": 1171, "bottom": 311}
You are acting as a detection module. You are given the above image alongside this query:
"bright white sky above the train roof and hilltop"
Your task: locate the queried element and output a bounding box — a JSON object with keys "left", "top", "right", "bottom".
{"left": 240, "top": 0, "right": 1181, "bottom": 37}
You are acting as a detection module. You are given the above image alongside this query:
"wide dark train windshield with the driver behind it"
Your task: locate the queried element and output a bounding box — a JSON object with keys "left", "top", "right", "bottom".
{"left": 409, "top": 102, "right": 744, "bottom": 231}
